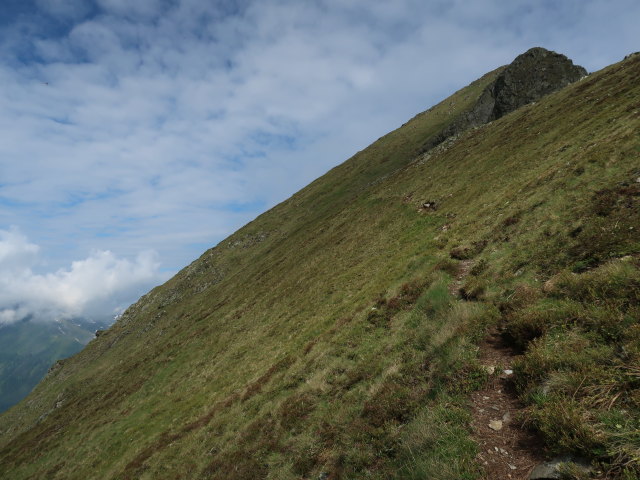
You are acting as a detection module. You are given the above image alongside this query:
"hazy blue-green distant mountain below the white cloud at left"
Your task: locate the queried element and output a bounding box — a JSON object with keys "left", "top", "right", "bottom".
{"left": 0, "top": 318, "right": 106, "bottom": 412}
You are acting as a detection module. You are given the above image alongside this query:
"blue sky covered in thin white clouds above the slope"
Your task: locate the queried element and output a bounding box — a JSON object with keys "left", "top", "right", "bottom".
{"left": 0, "top": 0, "right": 640, "bottom": 324}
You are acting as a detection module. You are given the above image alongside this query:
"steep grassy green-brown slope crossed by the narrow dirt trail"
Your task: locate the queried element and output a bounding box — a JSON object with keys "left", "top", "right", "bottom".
{"left": 0, "top": 55, "right": 640, "bottom": 480}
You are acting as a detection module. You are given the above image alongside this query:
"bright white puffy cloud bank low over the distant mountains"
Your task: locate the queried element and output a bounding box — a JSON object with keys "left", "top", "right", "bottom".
{"left": 0, "top": 228, "right": 165, "bottom": 326}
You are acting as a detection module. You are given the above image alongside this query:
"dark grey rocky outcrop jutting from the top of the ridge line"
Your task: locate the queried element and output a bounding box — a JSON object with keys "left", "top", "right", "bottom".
{"left": 423, "top": 47, "right": 587, "bottom": 151}
